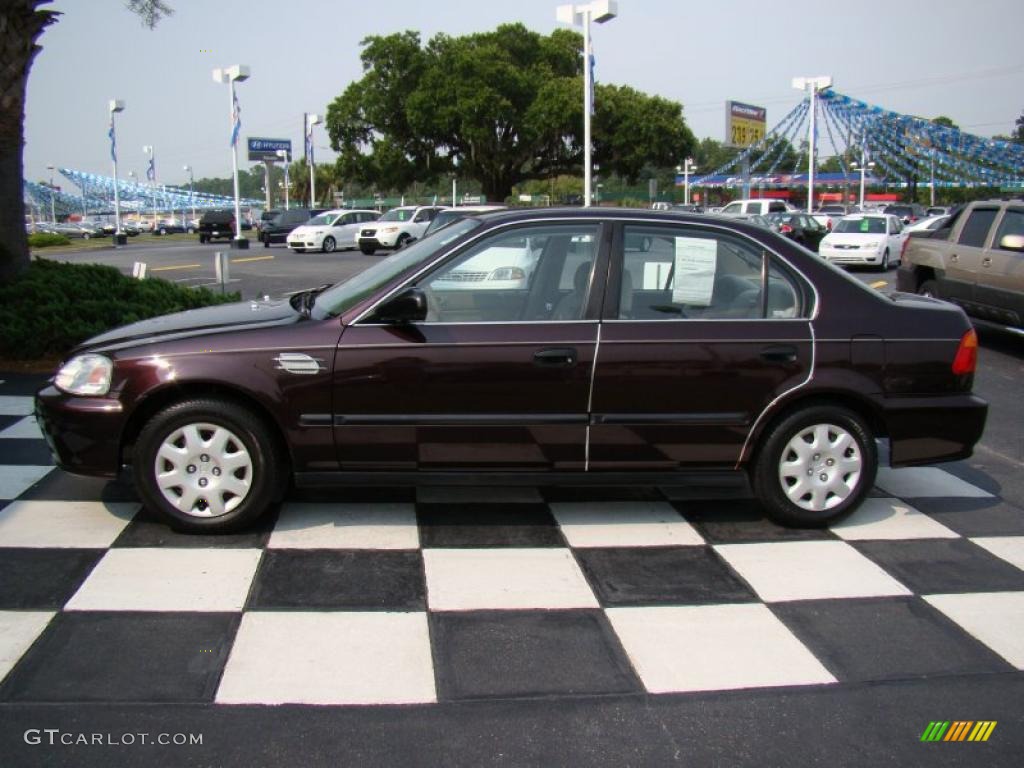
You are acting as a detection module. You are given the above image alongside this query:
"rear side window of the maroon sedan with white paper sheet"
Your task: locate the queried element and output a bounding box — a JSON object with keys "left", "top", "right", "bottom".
{"left": 617, "top": 224, "right": 801, "bottom": 321}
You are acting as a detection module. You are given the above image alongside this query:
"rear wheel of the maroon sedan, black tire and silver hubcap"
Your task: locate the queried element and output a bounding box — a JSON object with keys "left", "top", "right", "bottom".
{"left": 753, "top": 406, "right": 879, "bottom": 527}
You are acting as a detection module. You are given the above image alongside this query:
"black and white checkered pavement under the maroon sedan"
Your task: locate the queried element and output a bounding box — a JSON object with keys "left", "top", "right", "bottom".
{"left": 0, "top": 377, "right": 1024, "bottom": 705}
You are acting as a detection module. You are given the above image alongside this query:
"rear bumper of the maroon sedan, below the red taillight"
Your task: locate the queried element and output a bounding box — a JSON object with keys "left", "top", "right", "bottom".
{"left": 883, "top": 394, "right": 988, "bottom": 467}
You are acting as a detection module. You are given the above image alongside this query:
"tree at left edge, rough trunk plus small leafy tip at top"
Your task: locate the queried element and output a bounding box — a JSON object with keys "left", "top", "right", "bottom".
{"left": 0, "top": 0, "right": 172, "bottom": 283}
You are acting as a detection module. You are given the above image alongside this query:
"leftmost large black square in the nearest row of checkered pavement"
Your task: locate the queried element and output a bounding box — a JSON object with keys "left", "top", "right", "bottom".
{"left": 0, "top": 612, "right": 239, "bottom": 701}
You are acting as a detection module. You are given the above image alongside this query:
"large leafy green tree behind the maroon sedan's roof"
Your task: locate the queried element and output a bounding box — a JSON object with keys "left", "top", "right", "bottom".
{"left": 327, "top": 24, "right": 693, "bottom": 200}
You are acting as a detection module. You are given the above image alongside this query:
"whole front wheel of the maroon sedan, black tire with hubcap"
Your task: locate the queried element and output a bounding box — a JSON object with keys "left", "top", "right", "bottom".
{"left": 133, "top": 398, "right": 285, "bottom": 532}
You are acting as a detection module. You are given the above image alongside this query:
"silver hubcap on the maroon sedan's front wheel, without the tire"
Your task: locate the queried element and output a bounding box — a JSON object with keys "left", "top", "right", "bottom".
{"left": 154, "top": 423, "right": 253, "bottom": 517}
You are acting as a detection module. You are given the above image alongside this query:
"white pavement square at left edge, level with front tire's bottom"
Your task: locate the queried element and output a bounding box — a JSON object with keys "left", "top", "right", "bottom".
{"left": 0, "top": 501, "right": 139, "bottom": 549}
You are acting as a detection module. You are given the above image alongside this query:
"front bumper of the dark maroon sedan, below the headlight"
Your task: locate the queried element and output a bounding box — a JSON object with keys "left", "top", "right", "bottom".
{"left": 35, "top": 386, "right": 126, "bottom": 477}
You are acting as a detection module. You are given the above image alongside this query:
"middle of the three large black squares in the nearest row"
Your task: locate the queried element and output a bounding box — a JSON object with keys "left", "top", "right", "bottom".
{"left": 430, "top": 610, "right": 642, "bottom": 700}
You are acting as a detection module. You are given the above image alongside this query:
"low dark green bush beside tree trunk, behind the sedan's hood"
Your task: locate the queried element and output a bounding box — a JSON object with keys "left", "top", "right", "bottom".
{"left": 0, "top": 259, "right": 240, "bottom": 359}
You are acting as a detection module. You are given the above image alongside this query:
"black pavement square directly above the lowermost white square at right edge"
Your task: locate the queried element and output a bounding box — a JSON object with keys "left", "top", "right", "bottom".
{"left": 853, "top": 539, "right": 1024, "bottom": 595}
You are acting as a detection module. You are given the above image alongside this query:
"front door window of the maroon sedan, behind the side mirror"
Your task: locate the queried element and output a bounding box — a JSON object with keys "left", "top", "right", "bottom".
{"left": 419, "top": 224, "right": 598, "bottom": 324}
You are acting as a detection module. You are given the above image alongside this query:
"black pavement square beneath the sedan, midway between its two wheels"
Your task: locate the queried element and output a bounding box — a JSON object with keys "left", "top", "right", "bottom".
{"left": 416, "top": 504, "right": 565, "bottom": 548}
